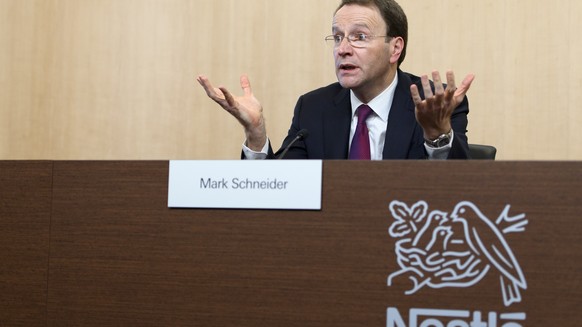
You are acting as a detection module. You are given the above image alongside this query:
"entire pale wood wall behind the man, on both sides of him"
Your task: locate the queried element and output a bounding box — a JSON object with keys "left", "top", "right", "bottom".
{"left": 0, "top": 0, "right": 582, "bottom": 160}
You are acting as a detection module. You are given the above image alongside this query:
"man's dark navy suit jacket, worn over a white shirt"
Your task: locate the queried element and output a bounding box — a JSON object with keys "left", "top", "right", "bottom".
{"left": 268, "top": 70, "right": 469, "bottom": 159}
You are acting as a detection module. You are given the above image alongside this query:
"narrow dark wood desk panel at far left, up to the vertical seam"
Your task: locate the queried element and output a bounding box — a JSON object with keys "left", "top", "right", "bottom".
{"left": 0, "top": 161, "right": 52, "bottom": 326}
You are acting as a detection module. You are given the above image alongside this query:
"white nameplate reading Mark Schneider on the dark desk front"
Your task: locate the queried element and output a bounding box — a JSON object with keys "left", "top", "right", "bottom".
{"left": 168, "top": 160, "right": 322, "bottom": 210}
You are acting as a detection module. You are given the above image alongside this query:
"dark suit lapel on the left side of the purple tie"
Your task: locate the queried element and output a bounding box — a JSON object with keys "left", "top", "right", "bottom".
{"left": 323, "top": 89, "right": 352, "bottom": 159}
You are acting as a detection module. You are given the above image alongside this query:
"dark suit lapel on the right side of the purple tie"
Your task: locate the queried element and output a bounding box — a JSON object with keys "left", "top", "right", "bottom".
{"left": 382, "top": 70, "right": 416, "bottom": 159}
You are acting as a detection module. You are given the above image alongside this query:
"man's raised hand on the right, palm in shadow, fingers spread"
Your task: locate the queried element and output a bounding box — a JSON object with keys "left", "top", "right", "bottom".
{"left": 410, "top": 71, "right": 475, "bottom": 139}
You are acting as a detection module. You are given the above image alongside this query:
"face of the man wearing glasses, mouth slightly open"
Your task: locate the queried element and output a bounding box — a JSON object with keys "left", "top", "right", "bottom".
{"left": 332, "top": 5, "right": 397, "bottom": 102}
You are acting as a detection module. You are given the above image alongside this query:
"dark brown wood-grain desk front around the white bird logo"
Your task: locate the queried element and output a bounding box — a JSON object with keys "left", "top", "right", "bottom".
{"left": 0, "top": 161, "right": 582, "bottom": 326}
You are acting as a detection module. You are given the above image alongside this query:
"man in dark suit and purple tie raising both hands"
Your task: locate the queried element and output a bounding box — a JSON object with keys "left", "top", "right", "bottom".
{"left": 198, "top": 0, "right": 474, "bottom": 160}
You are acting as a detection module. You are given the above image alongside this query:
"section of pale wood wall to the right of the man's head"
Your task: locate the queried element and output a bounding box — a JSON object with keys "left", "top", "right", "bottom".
{"left": 403, "top": 0, "right": 582, "bottom": 160}
